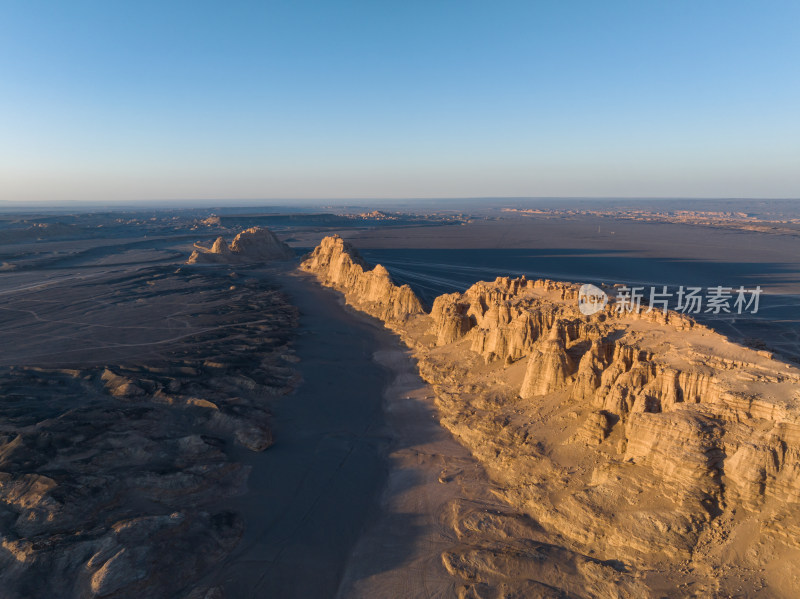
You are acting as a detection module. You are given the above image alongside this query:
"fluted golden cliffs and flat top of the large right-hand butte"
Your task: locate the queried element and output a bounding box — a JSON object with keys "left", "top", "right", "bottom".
{"left": 431, "top": 278, "right": 800, "bottom": 509}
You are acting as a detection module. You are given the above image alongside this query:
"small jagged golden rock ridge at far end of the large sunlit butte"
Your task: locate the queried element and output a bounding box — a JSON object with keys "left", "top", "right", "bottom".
{"left": 300, "top": 235, "right": 424, "bottom": 323}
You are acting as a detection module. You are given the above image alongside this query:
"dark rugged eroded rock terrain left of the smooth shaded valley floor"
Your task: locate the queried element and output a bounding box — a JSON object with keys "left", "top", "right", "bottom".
{"left": 0, "top": 266, "right": 298, "bottom": 599}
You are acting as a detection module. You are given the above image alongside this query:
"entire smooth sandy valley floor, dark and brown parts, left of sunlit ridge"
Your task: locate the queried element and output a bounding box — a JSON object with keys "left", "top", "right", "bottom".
{"left": 198, "top": 274, "right": 500, "bottom": 599}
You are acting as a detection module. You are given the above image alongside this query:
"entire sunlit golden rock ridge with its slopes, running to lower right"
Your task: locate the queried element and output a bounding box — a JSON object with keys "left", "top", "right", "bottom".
{"left": 301, "top": 236, "right": 800, "bottom": 597}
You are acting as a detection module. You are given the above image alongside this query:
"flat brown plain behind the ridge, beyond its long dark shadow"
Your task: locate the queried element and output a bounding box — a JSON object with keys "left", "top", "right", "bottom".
{"left": 293, "top": 216, "right": 800, "bottom": 294}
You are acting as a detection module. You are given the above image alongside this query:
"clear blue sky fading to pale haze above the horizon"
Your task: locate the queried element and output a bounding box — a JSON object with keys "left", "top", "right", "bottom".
{"left": 0, "top": 0, "right": 800, "bottom": 202}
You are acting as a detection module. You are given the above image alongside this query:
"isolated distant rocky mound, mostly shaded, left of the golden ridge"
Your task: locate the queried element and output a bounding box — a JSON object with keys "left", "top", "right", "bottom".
{"left": 187, "top": 227, "right": 295, "bottom": 264}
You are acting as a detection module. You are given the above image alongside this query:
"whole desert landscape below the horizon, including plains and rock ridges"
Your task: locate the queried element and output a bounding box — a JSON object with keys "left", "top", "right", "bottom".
{"left": 0, "top": 200, "right": 800, "bottom": 599}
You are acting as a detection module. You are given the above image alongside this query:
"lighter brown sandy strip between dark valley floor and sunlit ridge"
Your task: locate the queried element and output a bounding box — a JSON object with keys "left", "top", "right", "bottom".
{"left": 337, "top": 346, "right": 495, "bottom": 599}
